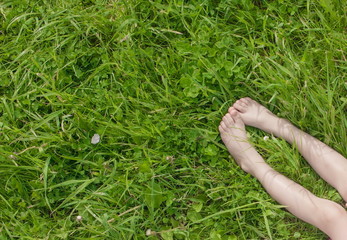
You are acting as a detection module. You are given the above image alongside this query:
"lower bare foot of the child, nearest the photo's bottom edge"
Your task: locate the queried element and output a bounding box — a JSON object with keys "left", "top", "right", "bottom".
{"left": 219, "top": 107, "right": 265, "bottom": 175}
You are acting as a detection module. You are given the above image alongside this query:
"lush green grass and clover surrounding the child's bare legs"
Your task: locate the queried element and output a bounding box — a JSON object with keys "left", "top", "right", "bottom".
{"left": 0, "top": 0, "right": 347, "bottom": 240}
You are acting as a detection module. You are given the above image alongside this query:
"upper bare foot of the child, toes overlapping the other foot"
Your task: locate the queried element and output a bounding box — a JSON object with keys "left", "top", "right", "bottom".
{"left": 229, "top": 97, "right": 291, "bottom": 135}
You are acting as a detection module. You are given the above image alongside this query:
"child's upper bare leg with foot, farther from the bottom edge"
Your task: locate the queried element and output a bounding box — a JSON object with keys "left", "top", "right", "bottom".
{"left": 230, "top": 98, "right": 347, "bottom": 201}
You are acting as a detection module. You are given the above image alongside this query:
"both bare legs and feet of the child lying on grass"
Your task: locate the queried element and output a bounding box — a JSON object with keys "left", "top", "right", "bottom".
{"left": 219, "top": 98, "right": 347, "bottom": 240}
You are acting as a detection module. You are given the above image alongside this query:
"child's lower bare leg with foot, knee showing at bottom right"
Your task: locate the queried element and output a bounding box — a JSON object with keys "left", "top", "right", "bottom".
{"left": 219, "top": 108, "right": 347, "bottom": 240}
